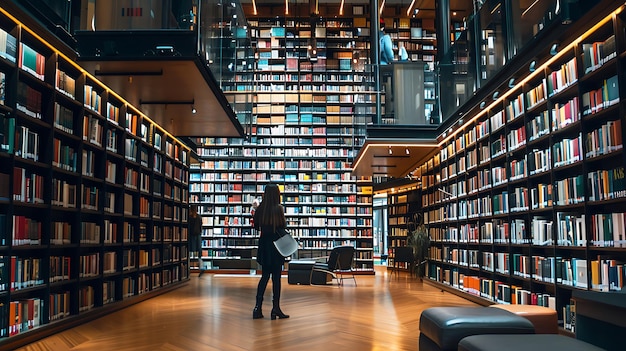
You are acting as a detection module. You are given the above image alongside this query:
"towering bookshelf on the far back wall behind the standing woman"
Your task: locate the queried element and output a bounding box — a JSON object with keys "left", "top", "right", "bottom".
{"left": 191, "top": 6, "right": 375, "bottom": 273}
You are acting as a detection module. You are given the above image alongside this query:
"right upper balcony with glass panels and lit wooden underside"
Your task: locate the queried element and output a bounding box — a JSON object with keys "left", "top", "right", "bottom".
{"left": 353, "top": 0, "right": 602, "bottom": 181}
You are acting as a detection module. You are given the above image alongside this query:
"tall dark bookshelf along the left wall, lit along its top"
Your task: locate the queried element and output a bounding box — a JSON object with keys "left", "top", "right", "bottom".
{"left": 0, "top": 9, "right": 190, "bottom": 347}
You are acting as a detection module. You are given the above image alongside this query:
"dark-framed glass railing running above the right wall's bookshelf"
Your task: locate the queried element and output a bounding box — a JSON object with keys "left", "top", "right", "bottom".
{"left": 435, "top": 0, "right": 599, "bottom": 120}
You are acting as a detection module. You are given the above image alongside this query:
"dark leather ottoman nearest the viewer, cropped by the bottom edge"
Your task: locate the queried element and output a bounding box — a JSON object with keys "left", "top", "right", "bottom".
{"left": 456, "top": 334, "right": 604, "bottom": 351}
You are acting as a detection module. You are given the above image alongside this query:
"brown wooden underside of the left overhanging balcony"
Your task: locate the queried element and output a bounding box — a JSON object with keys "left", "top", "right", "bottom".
{"left": 76, "top": 60, "right": 242, "bottom": 137}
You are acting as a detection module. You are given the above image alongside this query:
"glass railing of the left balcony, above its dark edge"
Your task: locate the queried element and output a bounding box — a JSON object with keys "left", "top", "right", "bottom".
{"left": 78, "top": 0, "right": 254, "bottom": 124}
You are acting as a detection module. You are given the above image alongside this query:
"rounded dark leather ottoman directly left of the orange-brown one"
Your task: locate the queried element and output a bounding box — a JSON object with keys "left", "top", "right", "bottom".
{"left": 419, "top": 307, "right": 535, "bottom": 351}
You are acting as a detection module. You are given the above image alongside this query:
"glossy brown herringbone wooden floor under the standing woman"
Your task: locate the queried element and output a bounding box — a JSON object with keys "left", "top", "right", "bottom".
{"left": 19, "top": 267, "right": 474, "bottom": 351}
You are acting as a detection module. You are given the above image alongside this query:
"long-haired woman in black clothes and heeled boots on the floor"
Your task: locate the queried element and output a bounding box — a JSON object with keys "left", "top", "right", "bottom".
{"left": 252, "top": 184, "right": 289, "bottom": 319}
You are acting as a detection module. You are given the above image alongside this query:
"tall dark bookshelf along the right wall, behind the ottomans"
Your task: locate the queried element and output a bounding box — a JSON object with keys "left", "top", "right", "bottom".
{"left": 419, "top": 4, "right": 626, "bottom": 330}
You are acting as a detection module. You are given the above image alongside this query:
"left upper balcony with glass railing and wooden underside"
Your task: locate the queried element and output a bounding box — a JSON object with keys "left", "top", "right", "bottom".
{"left": 6, "top": 0, "right": 250, "bottom": 137}
